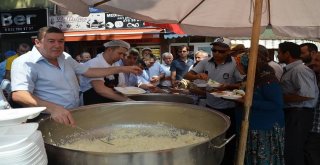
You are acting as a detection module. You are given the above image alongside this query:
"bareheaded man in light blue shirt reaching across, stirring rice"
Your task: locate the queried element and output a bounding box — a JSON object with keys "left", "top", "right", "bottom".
{"left": 11, "top": 27, "right": 141, "bottom": 126}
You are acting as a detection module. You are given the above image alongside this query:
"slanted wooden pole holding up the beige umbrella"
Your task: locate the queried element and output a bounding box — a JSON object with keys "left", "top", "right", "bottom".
{"left": 236, "top": 0, "right": 263, "bottom": 165}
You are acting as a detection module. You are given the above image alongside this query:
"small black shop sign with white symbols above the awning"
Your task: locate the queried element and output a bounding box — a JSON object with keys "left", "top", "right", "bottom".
{"left": 106, "top": 13, "right": 144, "bottom": 29}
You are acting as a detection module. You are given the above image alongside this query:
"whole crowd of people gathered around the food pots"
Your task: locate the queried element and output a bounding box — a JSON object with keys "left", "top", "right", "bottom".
{"left": 0, "top": 27, "right": 320, "bottom": 165}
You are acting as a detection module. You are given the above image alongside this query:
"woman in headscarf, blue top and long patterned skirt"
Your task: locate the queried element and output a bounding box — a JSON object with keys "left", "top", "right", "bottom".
{"left": 236, "top": 45, "right": 284, "bottom": 165}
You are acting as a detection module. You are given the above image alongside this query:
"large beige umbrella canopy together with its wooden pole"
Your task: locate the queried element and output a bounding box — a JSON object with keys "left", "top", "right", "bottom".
{"left": 51, "top": 0, "right": 320, "bottom": 164}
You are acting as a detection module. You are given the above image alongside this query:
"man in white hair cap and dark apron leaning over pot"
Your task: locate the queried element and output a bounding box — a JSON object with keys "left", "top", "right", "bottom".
{"left": 80, "top": 40, "right": 130, "bottom": 105}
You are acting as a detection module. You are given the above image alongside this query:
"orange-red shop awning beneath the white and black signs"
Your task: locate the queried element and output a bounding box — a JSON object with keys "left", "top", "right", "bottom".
{"left": 64, "top": 28, "right": 162, "bottom": 42}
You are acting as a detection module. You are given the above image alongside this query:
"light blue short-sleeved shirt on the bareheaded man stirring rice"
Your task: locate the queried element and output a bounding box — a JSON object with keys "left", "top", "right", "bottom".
{"left": 11, "top": 47, "right": 88, "bottom": 109}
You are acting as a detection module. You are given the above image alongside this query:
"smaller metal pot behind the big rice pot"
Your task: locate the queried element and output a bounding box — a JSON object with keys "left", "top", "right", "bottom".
{"left": 129, "top": 93, "right": 194, "bottom": 104}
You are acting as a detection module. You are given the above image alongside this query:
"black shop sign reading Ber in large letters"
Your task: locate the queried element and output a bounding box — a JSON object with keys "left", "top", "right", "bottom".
{"left": 0, "top": 9, "right": 48, "bottom": 33}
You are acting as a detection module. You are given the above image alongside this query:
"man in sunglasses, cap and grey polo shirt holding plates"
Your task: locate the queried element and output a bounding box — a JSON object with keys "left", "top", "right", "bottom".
{"left": 184, "top": 38, "right": 244, "bottom": 165}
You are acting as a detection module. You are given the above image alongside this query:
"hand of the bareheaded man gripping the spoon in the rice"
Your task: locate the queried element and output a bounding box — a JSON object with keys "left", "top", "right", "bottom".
{"left": 50, "top": 107, "right": 76, "bottom": 126}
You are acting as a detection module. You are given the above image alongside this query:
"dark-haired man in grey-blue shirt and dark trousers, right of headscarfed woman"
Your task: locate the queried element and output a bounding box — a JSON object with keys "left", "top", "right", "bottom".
{"left": 278, "top": 42, "right": 319, "bottom": 165}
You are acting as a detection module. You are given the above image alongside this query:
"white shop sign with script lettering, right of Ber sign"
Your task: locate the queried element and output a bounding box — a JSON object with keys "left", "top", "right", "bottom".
{"left": 49, "top": 13, "right": 106, "bottom": 31}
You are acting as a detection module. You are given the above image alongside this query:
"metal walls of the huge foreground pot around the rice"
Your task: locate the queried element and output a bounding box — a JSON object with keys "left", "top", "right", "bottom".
{"left": 39, "top": 101, "right": 230, "bottom": 165}
